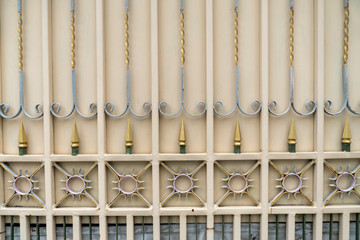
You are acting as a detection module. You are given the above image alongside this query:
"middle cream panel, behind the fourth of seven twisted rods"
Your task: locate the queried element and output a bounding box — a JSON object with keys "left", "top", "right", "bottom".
{"left": 159, "top": 0, "right": 205, "bottom": 153}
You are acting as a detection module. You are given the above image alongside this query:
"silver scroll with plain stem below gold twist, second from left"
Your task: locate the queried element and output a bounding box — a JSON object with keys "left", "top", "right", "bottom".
{"left": 50, "top": 69, "right": 97, "bottom": 118}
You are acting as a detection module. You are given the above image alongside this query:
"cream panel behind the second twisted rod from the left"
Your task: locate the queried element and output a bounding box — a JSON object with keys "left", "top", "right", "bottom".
{"left": 52, "top": 0, "right": 97, "bottom": 153}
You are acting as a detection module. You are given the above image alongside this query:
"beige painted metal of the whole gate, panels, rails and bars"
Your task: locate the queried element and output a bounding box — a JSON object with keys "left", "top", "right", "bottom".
{"left": 0, "top": 0, "right": 360, "bottom": 240}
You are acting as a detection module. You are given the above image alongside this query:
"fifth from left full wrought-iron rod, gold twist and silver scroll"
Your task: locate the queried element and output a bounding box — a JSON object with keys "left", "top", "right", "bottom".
{"left": 213, "top": 0, "right": 262, "bottom": 117}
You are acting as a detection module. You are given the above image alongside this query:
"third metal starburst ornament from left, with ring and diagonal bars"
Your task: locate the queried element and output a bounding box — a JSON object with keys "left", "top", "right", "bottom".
{"left": 106, "top": 163, "right": 151, "bottom": 207}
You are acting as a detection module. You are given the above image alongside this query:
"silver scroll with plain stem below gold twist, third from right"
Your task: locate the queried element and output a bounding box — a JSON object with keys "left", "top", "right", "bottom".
{"left": 213, "top": 66, "right": 262, "bottom": 117}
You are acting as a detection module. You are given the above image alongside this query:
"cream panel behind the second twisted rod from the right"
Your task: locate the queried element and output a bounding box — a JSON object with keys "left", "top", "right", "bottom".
{"left": 264, "top": 0, "right": 314, "bottom": 151}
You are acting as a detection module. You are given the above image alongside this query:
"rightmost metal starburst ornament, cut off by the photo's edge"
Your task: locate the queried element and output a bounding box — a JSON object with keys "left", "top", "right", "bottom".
{"left": 324, "top": 161, "right": 360, "bottom": 206}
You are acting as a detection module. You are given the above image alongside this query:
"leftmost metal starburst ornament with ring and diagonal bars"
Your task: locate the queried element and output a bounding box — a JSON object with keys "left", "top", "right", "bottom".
{"left": 0, "top": 163, "right": 45, "bottom": 207}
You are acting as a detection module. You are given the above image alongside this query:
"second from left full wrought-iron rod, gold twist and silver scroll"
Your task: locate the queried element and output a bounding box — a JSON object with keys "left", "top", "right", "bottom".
{"left": 50, "top": 0, "right": 97, "bottom": 118}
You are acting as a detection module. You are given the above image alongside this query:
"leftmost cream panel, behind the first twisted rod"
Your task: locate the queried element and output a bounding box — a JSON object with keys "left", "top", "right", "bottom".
{"left": 0, "top": 0, "right": 44, "bottom": 154}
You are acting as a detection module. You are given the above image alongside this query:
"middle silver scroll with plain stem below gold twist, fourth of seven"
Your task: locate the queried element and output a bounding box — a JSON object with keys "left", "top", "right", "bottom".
{"left": 158, "top": 67, "right": 207, "bottom": 117}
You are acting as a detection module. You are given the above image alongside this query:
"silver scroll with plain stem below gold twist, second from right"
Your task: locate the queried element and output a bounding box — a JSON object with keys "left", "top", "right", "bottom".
{"left": 268, "top": 67, "right": 317, "bottom": 116}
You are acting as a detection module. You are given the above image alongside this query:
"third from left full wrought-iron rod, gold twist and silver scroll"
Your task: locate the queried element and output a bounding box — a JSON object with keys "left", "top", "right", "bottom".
{"left": 104, "top": 0, "right": 152, "bottom": 118}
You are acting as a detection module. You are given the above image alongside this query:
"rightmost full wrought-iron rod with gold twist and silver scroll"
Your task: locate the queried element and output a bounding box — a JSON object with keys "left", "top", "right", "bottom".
{"left": 324, "top": 0, "right": 360, "bottom": 116}
